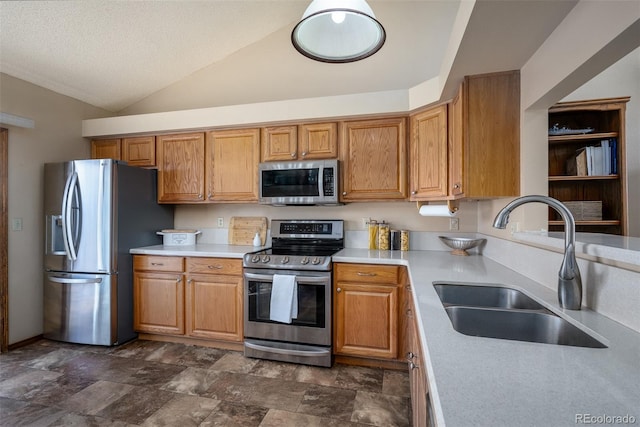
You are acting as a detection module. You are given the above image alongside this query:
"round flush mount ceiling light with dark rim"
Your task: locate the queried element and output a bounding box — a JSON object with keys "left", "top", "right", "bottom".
{"left": 291, "top": 0, "right": 386, "bottom": 63}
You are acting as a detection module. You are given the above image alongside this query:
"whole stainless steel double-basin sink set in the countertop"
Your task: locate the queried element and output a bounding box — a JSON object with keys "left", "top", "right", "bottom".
{"left": 433, "top": 282, "right": 607, "bottom": 348}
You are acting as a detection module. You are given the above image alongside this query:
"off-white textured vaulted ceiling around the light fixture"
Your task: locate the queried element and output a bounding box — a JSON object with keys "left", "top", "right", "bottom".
{"left": 0, "top": 0, "right": 575, "bottom": 114}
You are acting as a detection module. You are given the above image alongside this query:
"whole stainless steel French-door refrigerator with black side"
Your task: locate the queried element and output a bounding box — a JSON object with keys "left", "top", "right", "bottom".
{"left": 43, "top": 159, "right": 173, "bottom": 346}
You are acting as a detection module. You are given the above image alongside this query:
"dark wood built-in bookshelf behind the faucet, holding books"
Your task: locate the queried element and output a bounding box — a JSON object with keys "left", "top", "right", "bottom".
{"left": 549, "top": 97, "right": 629, "bottom": 235}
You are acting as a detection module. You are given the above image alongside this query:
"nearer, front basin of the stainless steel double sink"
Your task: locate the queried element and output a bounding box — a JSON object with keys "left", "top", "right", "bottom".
{"left": 446, "top": 306, "right": 607, "bottom": 348}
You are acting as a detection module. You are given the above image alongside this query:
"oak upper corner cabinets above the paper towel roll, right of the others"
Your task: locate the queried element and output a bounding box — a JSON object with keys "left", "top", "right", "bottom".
{"left": 411, "top": 71, "right": 520, "bottom": 200}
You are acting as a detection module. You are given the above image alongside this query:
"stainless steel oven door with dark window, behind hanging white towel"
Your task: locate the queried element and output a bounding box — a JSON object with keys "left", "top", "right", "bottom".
{"left": 244, "top": 269, "right": 331, "bottom": 346}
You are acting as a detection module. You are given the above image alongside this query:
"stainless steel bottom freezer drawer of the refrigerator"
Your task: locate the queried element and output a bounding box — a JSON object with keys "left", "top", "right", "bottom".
{"left": 43, "top": 272, "right": 117, "bottom": 345}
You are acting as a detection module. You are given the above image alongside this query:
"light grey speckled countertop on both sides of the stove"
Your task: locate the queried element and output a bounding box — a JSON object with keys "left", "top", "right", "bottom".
{"left": 131, "top": 244, "right": 640, "bottom": 427}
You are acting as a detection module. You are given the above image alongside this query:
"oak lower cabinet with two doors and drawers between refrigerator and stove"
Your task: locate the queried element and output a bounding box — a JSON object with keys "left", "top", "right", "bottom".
{"left": 133, "top": 255, "right": 243, "bottom": 342}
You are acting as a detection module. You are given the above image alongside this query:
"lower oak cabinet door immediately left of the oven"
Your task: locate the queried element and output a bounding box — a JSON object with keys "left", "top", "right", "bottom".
{"left": 186, "top": 274, "right": 243, "bottom": 341}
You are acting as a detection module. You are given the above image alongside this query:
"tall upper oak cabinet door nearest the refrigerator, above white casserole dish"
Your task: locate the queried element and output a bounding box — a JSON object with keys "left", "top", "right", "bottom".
{"left": 157, "top": 133, "right": 205, "bottom": 203}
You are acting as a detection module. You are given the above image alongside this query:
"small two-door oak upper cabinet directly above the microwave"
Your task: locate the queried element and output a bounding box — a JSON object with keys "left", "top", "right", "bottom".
{"left": 262, "top": 123, "right": 338, "bottom": 162}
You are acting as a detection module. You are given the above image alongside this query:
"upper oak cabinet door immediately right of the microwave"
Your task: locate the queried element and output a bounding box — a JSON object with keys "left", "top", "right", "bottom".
{"left": 340, "top": 118, "right": 407, "bottom": 202}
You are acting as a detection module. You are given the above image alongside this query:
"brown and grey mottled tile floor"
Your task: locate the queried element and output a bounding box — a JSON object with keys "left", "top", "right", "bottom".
{"left": 0, "top": 340, "right": 410, "bottom": 427}
